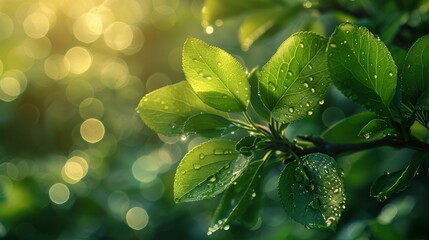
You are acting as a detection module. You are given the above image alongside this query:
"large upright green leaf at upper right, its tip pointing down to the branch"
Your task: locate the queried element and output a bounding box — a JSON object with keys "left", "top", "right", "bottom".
{"left": 327, "top": 23, "right": 397, "bottom": 117}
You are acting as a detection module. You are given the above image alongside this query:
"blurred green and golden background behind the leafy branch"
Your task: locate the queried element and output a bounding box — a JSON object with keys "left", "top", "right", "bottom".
{"left": 0, "top": 0, "right": 429, "bottom": 239}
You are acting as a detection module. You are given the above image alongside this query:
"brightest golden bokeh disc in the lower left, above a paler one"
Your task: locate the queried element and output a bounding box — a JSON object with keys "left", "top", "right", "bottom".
{"left": 61, "top": 156, "right": 88, "bottom": 184}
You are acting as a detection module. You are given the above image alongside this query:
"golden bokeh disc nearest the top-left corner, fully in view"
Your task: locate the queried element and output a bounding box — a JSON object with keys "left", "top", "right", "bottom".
{"left": 23, "top": 12, "right": 50, "bottom": 39}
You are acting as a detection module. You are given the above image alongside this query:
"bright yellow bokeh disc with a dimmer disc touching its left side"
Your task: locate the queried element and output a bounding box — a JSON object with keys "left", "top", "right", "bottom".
{"left": 65, "top": 46, "right": 92, "bottom": 74}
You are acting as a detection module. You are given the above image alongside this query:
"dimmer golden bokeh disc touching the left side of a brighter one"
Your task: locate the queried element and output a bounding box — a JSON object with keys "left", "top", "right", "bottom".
{"left": 44, "top": 54, "right": 70, "bottom": 80}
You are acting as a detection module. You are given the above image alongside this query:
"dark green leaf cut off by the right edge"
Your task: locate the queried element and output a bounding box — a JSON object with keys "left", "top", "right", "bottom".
{"left": 401, "top": 35, "right": 429, "bottom": 106}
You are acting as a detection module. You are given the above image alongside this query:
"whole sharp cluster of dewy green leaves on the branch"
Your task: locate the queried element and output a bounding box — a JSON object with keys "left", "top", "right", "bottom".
{"left": 137, "top": 22, "right": 429, "bottom": 235}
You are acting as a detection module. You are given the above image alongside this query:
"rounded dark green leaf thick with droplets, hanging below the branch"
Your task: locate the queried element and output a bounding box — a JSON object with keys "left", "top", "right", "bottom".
{"left": 279, "top": 153, "right": 345, "bottom": 230}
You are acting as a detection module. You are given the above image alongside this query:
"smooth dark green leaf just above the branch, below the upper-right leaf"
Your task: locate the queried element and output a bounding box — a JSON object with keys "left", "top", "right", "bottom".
{"left": 321, "top": 112, "right": 383, "bottom": 143}
